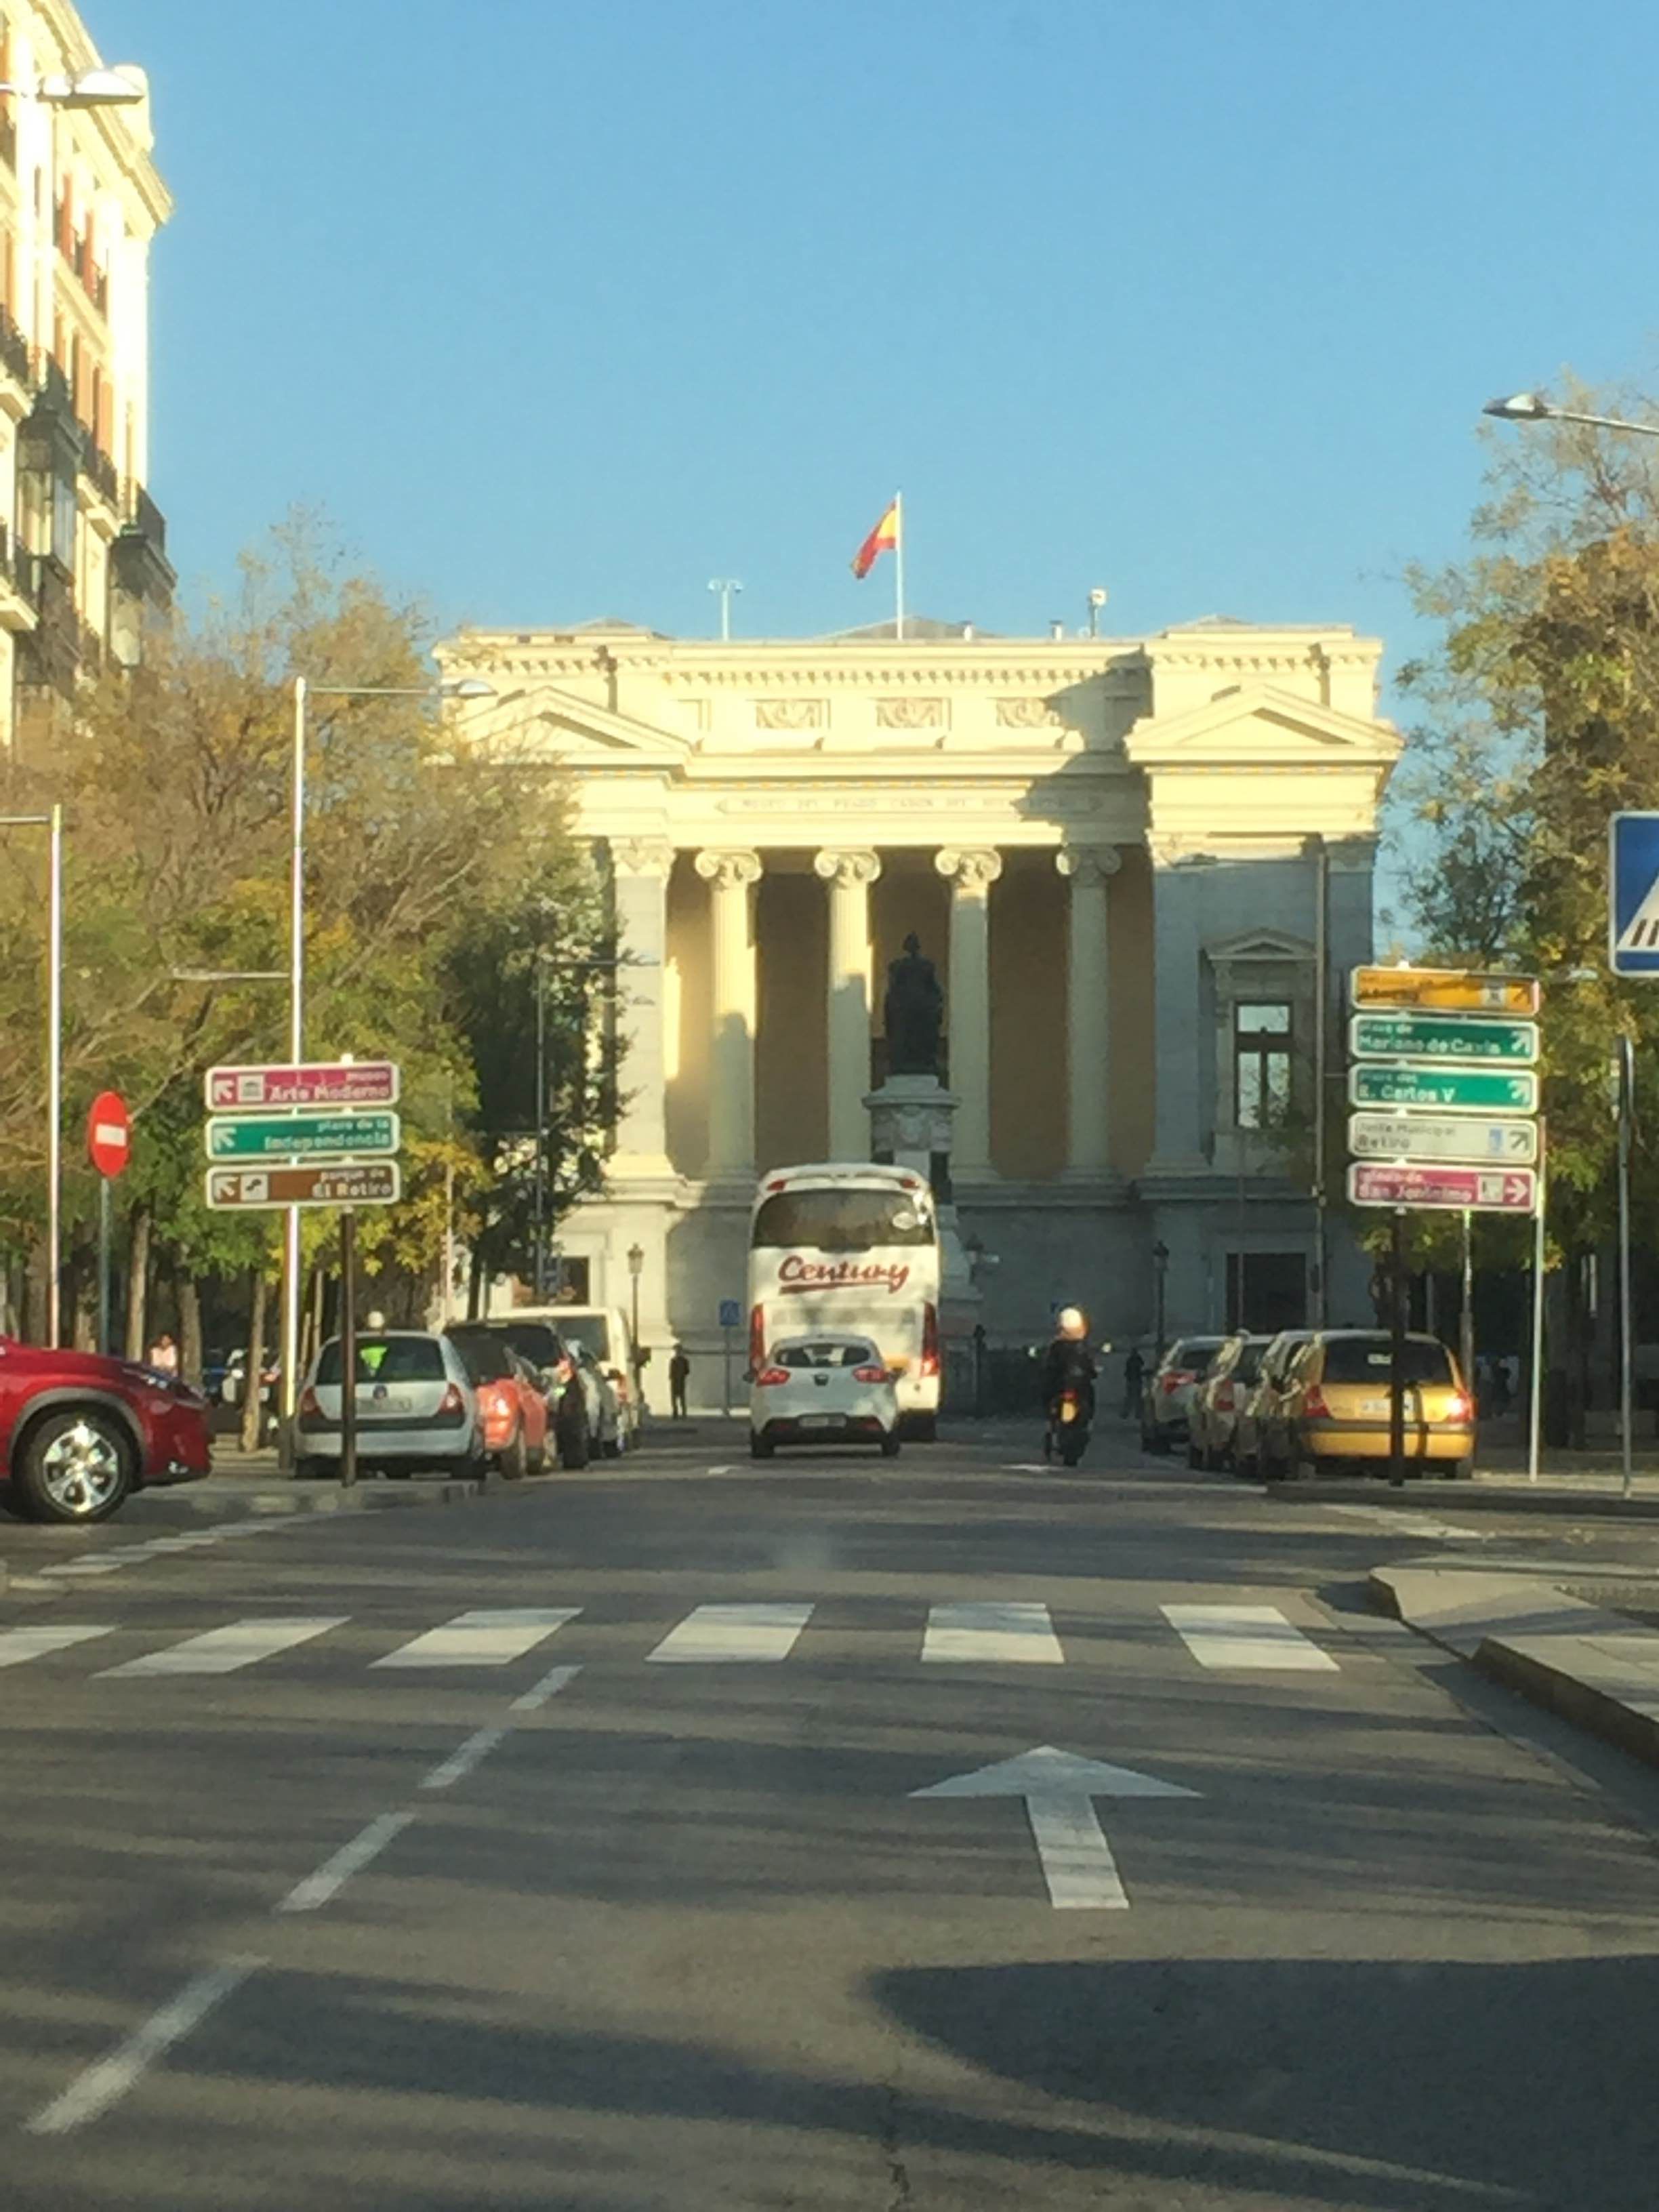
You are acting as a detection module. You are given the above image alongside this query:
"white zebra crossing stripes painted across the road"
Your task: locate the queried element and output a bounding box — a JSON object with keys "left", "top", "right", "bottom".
{"left": 0, "top": 1599, "right": 1340, "bottom": 1683}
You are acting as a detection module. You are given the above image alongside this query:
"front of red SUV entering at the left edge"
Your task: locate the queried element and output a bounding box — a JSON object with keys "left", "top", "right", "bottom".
{"left": 0, "top": 1336, "right": 212, "bottom": 1522}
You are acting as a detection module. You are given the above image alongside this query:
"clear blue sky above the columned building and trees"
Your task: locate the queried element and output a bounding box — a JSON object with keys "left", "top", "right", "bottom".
{"left": 94, "top": 0, "right": 1659, "bottom": 659}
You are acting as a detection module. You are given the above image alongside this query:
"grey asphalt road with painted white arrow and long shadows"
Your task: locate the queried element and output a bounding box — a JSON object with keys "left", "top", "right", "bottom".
{"left": 0, "top": 1435, "right": 1659, "bottom": 2212}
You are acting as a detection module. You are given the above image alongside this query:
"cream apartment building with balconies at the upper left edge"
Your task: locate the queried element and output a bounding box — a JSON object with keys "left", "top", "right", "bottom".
{"left": 0, "top": 0, "right": 175, "bottom": 747}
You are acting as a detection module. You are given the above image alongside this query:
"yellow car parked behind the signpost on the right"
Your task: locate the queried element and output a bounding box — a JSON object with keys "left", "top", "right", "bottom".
{"left": 1261, "top": 1330, "right": 1475, "bottom": 1482}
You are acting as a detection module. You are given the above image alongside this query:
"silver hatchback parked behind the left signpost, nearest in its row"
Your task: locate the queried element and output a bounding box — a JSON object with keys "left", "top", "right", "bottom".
{"left": 294, "top": 1330, "right": 487, "bottom": 1482}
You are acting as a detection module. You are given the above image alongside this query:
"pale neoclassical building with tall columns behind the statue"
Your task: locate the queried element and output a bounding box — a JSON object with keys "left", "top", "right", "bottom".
{"left": 443, "top": 619, "right": 1400, "bottom": 1349}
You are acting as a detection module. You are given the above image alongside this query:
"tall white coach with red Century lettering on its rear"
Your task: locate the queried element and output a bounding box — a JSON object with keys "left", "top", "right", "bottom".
{"left": 750, "top": 1162, "right": 940, "bottom": 1440}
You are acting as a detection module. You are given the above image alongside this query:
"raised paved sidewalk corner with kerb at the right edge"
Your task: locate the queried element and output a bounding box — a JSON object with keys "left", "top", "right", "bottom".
{"left": 1369, "top": 1566, "right": 1659, "bottom": 1765}
